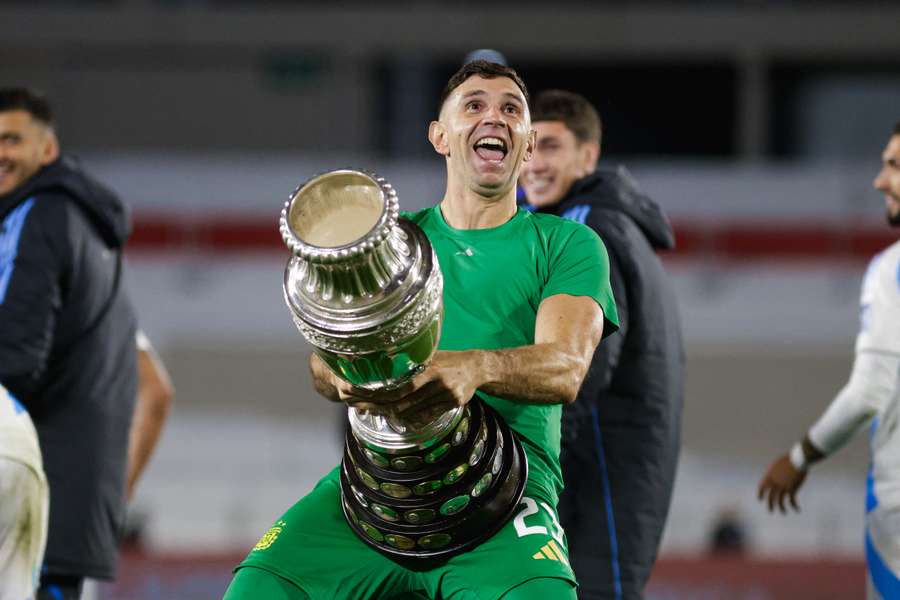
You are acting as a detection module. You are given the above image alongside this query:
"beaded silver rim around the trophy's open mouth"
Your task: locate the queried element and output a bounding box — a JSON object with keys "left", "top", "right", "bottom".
{"left": 278, "top": 167, "right": 400, "bottom": 263}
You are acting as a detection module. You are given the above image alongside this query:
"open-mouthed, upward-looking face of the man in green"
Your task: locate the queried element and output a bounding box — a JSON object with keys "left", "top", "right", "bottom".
{"left": 429, "top": 75, "right": 534, "bottom": 197}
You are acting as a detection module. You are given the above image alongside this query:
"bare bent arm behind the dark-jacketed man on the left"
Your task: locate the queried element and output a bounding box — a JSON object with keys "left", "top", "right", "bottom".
{"left": 127, "top": 331, "right": 175, "bottom": 499}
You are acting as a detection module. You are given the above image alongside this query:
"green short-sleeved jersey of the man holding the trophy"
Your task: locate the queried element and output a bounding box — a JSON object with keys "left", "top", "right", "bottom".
{"left": 403, "top": 206, "right": 618, "bottom": 504}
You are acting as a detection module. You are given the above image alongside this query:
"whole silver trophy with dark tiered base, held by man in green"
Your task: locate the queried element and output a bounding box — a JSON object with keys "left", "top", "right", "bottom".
{"left": 280, "top": 169, "right": 528, "bottom": 567}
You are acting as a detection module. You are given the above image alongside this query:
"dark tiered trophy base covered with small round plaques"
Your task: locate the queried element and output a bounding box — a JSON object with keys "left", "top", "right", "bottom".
{"left": 341, "top": 398, "right": 528, "bottom": 570}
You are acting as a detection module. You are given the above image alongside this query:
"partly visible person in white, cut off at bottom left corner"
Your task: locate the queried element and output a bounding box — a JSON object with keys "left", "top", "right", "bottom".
{"left": 0, "top": 386, "right": 49, "bottom": 600}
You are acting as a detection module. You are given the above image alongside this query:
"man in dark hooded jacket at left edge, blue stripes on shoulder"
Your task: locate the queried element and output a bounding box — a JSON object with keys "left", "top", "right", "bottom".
{"left": 0, "top": 88, "right": 137, "bottom": 600}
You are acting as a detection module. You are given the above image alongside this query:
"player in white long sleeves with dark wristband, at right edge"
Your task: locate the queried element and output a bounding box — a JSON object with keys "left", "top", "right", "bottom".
{"left": 758, "top": 122, "right": 900, "bottom": 600}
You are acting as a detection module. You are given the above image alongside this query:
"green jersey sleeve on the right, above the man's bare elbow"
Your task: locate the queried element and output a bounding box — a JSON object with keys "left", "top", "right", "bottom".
{"left": 541, "top": 222, "right": 619, "bottom": 338}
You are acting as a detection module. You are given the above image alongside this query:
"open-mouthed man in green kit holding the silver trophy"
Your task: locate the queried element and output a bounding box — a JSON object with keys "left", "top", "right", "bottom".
{"left": 225, "top": 61, "right": 617, "bottom": 600}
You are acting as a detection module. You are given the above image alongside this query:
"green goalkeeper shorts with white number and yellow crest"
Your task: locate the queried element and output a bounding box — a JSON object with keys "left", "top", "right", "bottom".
{"left": 228, "top": 468, "right": 575, "bottom": 600}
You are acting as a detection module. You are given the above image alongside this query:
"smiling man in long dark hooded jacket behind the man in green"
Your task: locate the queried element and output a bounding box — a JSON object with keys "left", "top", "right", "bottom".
{"left": 520, "top": 90, "right": 684, "bottom": 600}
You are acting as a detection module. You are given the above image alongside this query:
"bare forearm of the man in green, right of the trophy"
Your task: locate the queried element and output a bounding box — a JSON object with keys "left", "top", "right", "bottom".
{"left": 476, "top": 343, "right": 589, "bottom": 404}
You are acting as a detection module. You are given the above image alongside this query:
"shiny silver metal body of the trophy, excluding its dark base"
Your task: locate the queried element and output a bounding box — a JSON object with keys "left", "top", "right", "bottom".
{"left": 280, "top": 169, "right": 463, "bottom": 454}
